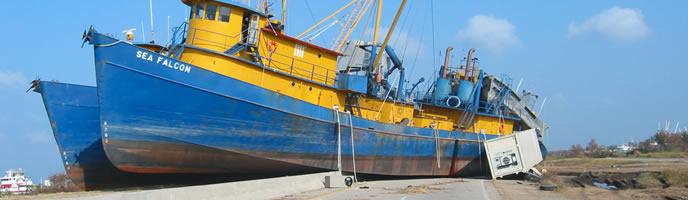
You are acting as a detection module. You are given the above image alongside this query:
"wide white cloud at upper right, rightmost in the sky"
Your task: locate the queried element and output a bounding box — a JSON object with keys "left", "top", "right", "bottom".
{"left": 567, "top": 6, "right": 650, "bottom": 41}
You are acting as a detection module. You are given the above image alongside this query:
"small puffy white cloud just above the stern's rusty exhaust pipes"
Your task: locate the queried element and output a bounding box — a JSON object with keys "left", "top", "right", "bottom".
{"left": 457, "top": 15, "right": 521, "bottom": 51}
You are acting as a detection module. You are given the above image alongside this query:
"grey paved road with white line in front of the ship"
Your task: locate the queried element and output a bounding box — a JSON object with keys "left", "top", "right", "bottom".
{"left": 280, "top": 178, "right": 564, "bottom": 200}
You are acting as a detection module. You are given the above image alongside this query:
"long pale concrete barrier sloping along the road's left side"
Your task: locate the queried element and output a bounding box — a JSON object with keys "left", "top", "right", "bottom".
{"left": 71, "top": 172, "right": 336, "bottom": 200}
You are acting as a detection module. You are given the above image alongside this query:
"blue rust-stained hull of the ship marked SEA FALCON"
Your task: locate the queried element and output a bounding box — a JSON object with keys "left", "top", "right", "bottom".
{"left": 89, "top": 32, "right": 495, "bottom": 176}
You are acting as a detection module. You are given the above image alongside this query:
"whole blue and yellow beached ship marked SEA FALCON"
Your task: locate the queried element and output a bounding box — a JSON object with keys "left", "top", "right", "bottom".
{"left": 84, "top": 0, "right": 545, "bottom": 176}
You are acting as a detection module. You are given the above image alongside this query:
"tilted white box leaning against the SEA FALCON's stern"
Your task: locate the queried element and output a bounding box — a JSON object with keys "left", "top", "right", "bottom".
{"left": 484, "top": 129, "right": 542, "bottom": 179}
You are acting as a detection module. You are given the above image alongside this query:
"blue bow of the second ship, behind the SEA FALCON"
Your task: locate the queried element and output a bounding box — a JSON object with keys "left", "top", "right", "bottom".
{"left": 34, "top": 80, "right": 109, "bottom": 189}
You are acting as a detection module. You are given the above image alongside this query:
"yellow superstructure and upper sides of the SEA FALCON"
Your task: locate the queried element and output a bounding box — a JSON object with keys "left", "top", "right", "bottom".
{"left": 179, "top": 0, "right": 514, "bottom": 134}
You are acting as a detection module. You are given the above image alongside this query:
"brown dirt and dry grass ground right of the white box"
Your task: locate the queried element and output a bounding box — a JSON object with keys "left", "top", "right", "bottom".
{"left": 538, "top": 158, "right": 688, "bottom": 200}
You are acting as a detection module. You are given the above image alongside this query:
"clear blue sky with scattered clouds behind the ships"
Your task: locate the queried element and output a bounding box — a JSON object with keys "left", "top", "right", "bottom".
{"left": 0, "top": 0, "right": 688, "bottom": 178}
